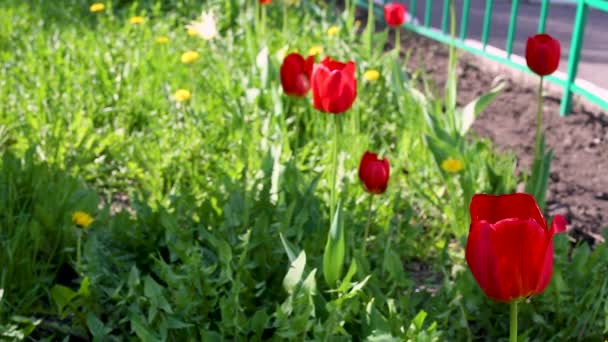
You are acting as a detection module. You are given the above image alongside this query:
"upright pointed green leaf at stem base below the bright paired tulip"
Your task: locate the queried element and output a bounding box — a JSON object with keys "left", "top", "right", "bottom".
{"left": 323, "top": 201, "right": 345, "bottom": 287}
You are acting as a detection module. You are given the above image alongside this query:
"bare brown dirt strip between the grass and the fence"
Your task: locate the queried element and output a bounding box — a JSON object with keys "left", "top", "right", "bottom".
{"left": 389, "top": 30, "right": 608, "bottom": 243}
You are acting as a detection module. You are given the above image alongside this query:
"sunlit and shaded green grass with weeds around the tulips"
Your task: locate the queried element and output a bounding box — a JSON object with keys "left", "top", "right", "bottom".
{"left": 0, "top": 0, "right": 608, "bottom": 341}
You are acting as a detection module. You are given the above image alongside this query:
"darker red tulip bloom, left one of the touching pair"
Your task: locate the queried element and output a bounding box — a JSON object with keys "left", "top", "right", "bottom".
{"left": 281, "top": 52, "right": 315, "bottom": 97}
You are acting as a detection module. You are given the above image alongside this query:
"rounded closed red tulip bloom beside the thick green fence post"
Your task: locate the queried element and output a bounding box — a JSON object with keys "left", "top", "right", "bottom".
{"left": 526, "top": 34, "right": 561, "bottom": 76}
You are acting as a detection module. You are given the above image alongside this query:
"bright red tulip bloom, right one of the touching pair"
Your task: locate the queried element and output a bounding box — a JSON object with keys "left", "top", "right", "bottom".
{"left": 312, "top": 57, "right": 357, "bottom": 114}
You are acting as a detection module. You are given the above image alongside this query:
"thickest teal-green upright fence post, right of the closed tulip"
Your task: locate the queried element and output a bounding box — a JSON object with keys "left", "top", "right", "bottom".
{"left": 559, "top": 0, "right": 588, "bottom": 116}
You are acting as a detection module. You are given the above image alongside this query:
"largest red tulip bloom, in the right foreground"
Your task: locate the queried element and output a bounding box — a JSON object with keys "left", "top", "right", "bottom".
{"left": 466, "top": 193, "right": 566, "bottom": 302}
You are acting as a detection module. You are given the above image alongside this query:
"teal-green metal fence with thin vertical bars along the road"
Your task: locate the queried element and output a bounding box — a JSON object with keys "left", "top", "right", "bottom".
{"left": 357, "top": 0, "right": 608, "bottom": 115}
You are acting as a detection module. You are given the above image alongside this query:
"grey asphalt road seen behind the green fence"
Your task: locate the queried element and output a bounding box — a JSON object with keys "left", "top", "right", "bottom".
{"left": 404, "top": 0, "right": 608, "bottom": 89}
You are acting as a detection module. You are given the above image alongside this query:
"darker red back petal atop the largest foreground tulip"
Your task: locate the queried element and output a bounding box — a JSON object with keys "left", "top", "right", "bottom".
{"left": 469, "top": 193, "right": 547, "bottom": 229}
